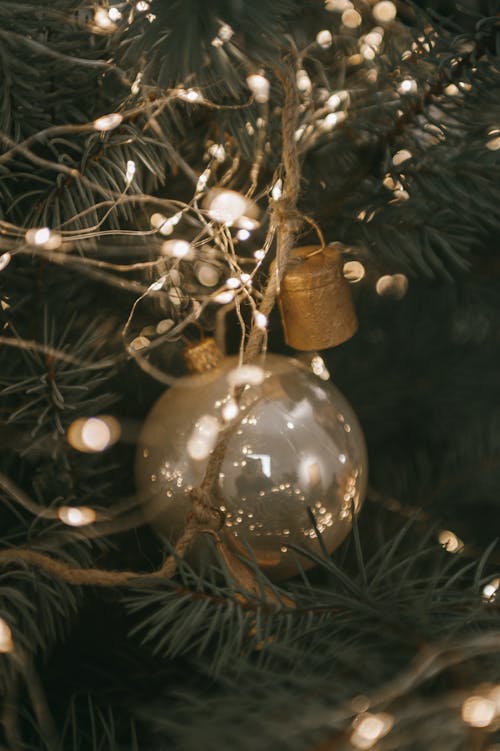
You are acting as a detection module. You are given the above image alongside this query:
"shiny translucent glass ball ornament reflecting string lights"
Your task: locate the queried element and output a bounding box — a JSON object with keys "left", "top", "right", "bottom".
{"left": 136, "top": 355, "right": 367, "bottom": 581}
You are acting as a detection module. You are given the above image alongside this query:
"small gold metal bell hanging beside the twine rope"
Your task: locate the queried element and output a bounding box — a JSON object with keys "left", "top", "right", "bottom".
{"left": 278, "top": 245, "right": 358, "bottom": 352}
